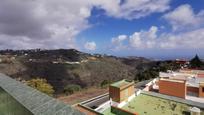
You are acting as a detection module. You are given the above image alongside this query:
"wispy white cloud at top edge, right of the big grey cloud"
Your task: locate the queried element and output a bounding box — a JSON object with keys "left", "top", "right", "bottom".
{"left": 96, "top": 0, "right": 170, "bottom": 20}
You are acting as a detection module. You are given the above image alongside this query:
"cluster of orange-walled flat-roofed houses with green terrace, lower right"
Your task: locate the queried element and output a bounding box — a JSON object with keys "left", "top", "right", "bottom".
{"left": 77, "top": 69, "right": 204, "bottom": 115}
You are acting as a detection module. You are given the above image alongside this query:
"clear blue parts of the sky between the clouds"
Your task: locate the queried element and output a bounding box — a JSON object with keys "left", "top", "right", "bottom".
{"left": 77, "top": 0, "right": 204, "bottom": 59}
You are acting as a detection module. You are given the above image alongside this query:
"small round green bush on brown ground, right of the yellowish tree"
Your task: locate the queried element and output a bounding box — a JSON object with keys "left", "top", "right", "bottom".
{"left": 64, "top": 84, "right": 81, "bottom": 95}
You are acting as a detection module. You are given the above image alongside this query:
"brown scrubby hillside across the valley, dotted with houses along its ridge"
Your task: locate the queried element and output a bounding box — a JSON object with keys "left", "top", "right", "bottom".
{"left": 0, "top": 49, "right": 155, "bottom": 94}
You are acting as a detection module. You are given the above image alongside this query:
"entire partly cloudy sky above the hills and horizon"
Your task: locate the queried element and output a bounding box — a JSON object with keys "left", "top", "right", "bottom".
{"left": 0, "top": 0, "right": 204, "bottom": 59}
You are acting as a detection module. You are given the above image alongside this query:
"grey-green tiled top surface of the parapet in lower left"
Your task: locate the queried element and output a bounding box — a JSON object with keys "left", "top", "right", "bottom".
{"left": 0, "top": 73, "right": 83, "bottom": 115}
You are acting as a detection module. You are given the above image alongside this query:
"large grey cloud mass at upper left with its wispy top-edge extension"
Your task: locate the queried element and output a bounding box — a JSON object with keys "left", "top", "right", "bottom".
{"left": 0, "top": 0, "right": 170, "bottom": 49}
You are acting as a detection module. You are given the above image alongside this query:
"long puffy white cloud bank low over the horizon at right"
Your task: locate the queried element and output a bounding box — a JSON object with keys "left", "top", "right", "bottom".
{"left": 112, "top": 26, "right": 204, "bottom": 50}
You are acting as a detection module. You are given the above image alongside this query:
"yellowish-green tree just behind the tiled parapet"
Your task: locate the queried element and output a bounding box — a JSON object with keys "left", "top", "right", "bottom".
{"left": 26, "top": 78, "right": 54, "bottom": 96}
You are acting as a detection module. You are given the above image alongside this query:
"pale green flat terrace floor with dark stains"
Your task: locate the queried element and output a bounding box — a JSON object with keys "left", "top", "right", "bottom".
{"left": 103, "top": 94, "right": 204, "bottom": 115}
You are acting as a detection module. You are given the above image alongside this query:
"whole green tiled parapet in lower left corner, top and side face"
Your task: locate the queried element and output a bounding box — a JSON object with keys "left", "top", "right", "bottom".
{"left": 0, "top": 73, "right": 84, "bottom": 115}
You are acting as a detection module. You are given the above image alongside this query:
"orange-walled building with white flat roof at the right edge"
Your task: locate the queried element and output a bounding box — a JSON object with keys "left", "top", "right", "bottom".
{"left": 159, "top": 69, "right": 204, "bottom": 101}
